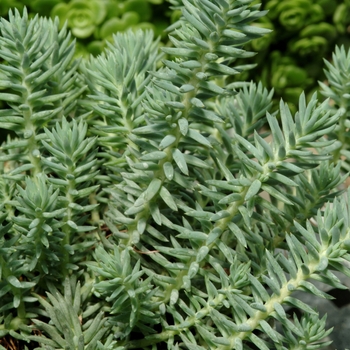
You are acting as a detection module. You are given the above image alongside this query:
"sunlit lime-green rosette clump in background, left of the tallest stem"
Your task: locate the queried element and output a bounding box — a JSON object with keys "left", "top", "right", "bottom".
{"left": 51, "top": 0, "right": 168, "bottom": 56}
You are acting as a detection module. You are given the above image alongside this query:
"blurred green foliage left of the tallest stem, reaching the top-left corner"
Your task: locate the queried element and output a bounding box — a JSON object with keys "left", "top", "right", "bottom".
{"left": 0, "top": 0, "right": 170, "bottom": 58}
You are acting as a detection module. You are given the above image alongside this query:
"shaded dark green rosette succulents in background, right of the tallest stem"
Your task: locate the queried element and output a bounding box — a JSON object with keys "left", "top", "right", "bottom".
{"left": 232, "top": 0, "right": 350, "bottom": 112}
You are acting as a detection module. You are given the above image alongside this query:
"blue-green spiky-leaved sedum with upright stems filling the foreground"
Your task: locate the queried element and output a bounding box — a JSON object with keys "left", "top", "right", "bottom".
{"left": 0, "top": 0, "right": 350, "bottom": 350}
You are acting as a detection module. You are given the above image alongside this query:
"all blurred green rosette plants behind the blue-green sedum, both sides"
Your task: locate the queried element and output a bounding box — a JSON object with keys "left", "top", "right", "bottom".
{"left": 0, "top": 0, "right": 350, "bottom": 112}
